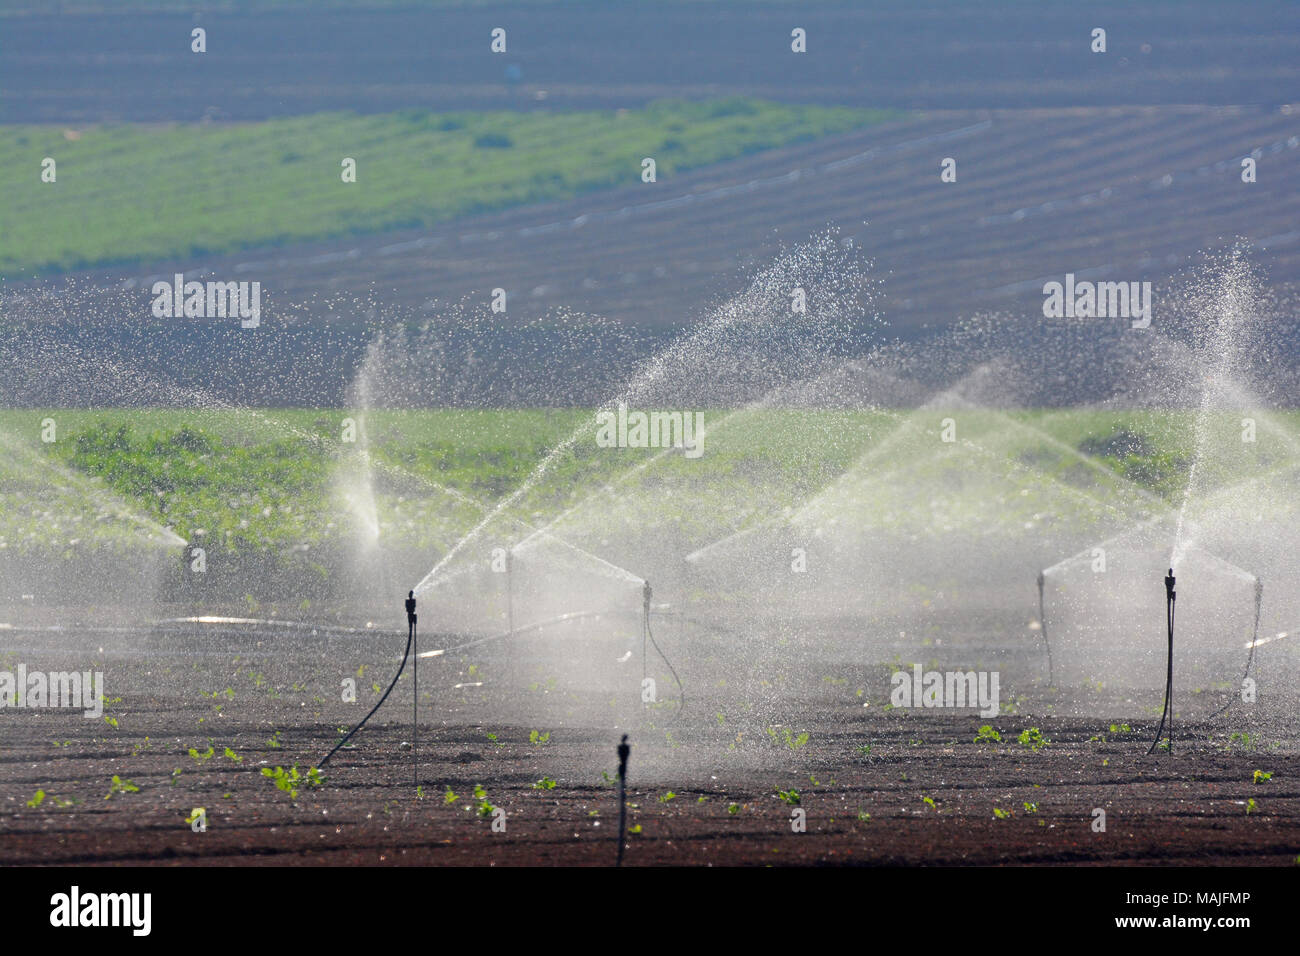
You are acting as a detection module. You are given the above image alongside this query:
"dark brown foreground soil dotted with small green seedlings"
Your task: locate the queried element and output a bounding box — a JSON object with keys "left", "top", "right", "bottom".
{"left": 0, "top": 616, "right": 1300, "bottom": 865}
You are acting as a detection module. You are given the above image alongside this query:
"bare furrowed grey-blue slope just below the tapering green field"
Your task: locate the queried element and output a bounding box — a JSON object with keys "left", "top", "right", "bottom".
{"left": 17, "top": 108, "right": 1300, "bottom": 405}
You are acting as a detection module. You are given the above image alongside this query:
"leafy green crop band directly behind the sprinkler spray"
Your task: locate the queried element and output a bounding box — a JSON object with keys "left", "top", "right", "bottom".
{"left": 0, "top": 408, "right": 1300, "bottom": 564}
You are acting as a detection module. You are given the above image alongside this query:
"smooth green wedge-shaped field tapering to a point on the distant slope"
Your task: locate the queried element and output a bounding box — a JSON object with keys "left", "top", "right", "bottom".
{"left": 0, "top": 99, "right": 898, "bottom": 277}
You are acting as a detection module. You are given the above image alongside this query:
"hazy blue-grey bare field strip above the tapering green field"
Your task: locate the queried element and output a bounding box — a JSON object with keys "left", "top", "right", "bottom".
{"left": 0, "top": 0, "right": 1300, "bottom": 122}
